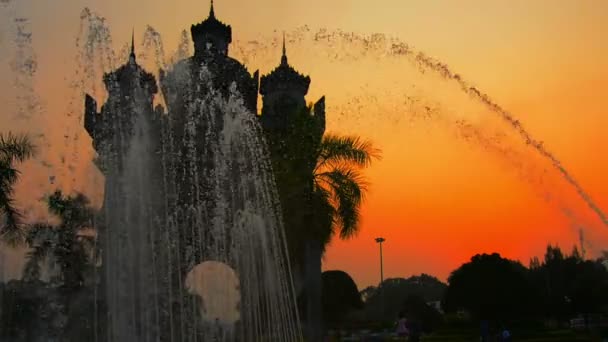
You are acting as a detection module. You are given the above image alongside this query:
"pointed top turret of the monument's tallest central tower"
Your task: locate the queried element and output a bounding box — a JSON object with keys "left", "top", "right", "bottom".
{"left": 190, "top": 0, "right": 232, "bottom": 57}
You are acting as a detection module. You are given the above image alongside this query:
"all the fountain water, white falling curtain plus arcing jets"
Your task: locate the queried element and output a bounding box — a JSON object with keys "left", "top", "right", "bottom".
{"left": 0, "top": 0, "right": 608, "bottom": 342}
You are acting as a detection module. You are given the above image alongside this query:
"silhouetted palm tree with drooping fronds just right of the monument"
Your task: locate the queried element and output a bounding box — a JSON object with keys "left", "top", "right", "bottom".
{"left": 305, "top": 135, "right": 380, "bottom": 341}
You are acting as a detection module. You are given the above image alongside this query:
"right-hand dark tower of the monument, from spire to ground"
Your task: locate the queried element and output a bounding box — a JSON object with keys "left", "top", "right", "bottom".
{"left": 260, "top": 36, "right": 325, "bottom": 341}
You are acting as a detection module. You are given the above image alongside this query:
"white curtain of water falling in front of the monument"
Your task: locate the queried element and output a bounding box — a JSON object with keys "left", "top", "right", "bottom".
{"left": 96, "top": 63, "right": 299, "bottom": 341}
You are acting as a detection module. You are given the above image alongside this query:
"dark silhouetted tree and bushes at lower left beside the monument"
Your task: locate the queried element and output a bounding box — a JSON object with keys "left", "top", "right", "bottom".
{"left": 0, "top": 191, "right": 96, "bottom": 341}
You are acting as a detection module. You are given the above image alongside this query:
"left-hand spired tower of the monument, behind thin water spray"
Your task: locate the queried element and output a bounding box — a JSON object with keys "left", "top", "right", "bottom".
{"left": 84, "top": 37, "right": 164, "bottom": 340}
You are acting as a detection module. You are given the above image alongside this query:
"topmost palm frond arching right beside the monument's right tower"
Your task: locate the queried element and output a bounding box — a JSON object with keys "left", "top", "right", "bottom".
{"left": 316, "top": 134, "right": 381, "bottom": 170}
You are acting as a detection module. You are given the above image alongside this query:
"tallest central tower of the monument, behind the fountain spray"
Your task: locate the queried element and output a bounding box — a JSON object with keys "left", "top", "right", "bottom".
{"left": 160, "top": 2, "right": 259, "bottom": 341}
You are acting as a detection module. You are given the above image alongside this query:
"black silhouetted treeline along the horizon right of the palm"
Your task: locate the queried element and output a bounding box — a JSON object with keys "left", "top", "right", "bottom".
{"left": 323, "top": 245, "right": 608, "bottom": 340}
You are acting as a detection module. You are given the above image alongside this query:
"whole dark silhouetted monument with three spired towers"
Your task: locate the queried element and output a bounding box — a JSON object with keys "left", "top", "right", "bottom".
{"left": 85, "top": 2, "right": 325, "bottom": 342}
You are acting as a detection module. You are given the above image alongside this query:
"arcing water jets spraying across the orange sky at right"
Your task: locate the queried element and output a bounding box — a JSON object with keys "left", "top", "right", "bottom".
{"left": 233, "top": 26, "right": 608, "bottom": 235}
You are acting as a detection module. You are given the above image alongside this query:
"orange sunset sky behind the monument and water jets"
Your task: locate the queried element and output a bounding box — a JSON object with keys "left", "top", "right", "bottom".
{"left": 0, "top": 0, "right": 608, "bottom": 289}
